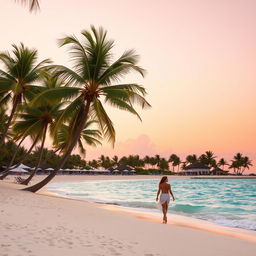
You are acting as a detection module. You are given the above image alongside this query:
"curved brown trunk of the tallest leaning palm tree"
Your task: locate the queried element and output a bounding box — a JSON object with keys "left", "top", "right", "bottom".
{"left": 23, "top": 100, "right": 91, "bottom": 193}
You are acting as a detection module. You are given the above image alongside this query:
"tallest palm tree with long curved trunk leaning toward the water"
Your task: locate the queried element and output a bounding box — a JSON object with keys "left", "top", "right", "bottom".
{"left": 26, "top": 26, "right": 150, "bottom": 192}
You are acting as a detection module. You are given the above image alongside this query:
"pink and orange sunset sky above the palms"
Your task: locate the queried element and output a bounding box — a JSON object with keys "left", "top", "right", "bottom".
{"left": 0, "top": 0, "right": 256, "bottom": 171}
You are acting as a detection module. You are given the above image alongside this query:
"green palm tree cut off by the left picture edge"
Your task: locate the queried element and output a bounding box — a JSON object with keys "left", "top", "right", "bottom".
{"left": 0, "top": 43, "right": 50, "bottom": 147}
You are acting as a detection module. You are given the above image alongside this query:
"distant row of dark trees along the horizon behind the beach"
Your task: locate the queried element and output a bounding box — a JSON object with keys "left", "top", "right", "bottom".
{"left": 0, "top": 141, "right": 252, "bottom": 175}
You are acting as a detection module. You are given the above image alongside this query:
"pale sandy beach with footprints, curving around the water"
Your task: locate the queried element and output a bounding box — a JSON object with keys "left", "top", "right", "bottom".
{"left": 0, "top": 176, "right": 256, "bottom": 256}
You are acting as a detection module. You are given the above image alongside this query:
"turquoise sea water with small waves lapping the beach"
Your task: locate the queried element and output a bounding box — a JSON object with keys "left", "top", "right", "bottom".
{"left": 48, "top": 179, "right": 256, "bottom": 230}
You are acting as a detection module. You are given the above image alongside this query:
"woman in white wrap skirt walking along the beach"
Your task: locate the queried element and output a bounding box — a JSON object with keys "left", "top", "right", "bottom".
{"left": 156, "top": 176, "right": 175, "bottom": 224}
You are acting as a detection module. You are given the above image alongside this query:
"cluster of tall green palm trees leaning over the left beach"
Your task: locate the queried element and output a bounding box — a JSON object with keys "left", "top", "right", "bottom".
{"left": 0, "top": 26, "right": 150, "bottom": 192}
